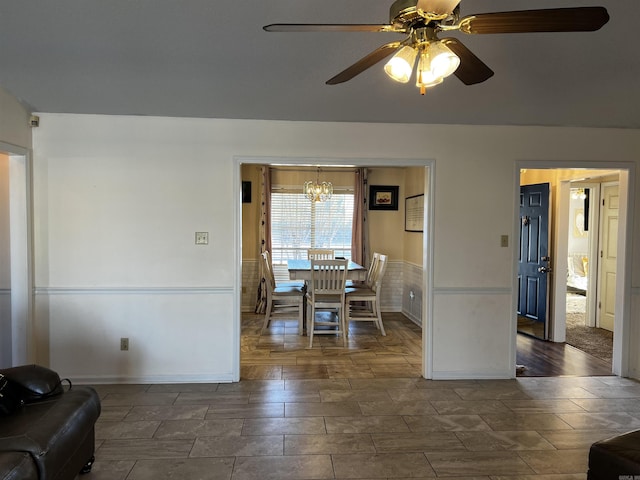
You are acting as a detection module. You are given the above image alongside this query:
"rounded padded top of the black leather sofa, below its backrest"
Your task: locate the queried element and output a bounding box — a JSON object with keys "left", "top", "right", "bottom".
{"left": 0, "top": 387, "right": 100, "bottom": 478}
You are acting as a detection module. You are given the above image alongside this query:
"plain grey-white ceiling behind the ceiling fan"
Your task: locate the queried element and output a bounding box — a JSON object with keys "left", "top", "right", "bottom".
{"left": 0, "top": 0, "right": 640, "bottom": 128}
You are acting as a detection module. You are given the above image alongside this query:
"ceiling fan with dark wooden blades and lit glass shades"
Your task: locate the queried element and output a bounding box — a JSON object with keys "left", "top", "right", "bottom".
{"left": 263, "top": 0, "right": 609, "bottom": 94}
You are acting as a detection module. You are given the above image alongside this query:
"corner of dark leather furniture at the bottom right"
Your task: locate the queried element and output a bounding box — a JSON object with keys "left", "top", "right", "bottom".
{"left": 587, "top": 430, "right": 640, "bottom": 480}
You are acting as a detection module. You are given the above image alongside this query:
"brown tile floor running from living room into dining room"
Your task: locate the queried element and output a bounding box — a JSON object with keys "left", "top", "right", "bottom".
{"left": 82, "top": 316, "right": 640, "bottom": 480}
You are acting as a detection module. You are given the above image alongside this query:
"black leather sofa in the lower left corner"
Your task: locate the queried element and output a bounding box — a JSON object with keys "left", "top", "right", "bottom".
{"left": 0, "top": 365, "right": 100, "bottom": 480}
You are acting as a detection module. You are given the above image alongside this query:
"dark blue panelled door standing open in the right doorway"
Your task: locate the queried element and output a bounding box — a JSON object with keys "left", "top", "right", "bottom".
{"left": 518, "top": 183, "right": 550, "bottom": 340}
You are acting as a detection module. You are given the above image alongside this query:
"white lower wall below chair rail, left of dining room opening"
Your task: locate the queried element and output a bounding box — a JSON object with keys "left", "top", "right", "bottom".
{"left": 36, "top": 287, "right": 239, "bottom": 383}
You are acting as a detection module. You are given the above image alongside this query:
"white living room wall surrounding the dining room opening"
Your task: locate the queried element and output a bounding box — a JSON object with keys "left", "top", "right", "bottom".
{"left": 34, "top": 114, "right": 640, "bottom": 381}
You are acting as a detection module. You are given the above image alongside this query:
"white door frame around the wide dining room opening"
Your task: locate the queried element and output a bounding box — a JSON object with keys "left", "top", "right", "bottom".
{"left": 233, "top": 156, "right": 436, "bottom": 381}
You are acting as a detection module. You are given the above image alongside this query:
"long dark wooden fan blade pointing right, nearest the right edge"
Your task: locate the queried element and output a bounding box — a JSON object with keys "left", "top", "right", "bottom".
{"left": 460, "top": 7, "right": 609, "bottom": 33}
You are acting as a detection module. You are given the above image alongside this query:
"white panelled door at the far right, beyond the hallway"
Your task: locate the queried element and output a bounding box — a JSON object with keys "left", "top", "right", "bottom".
{"left": 597, "top": 182, "right": 620, "bottom": 331}
